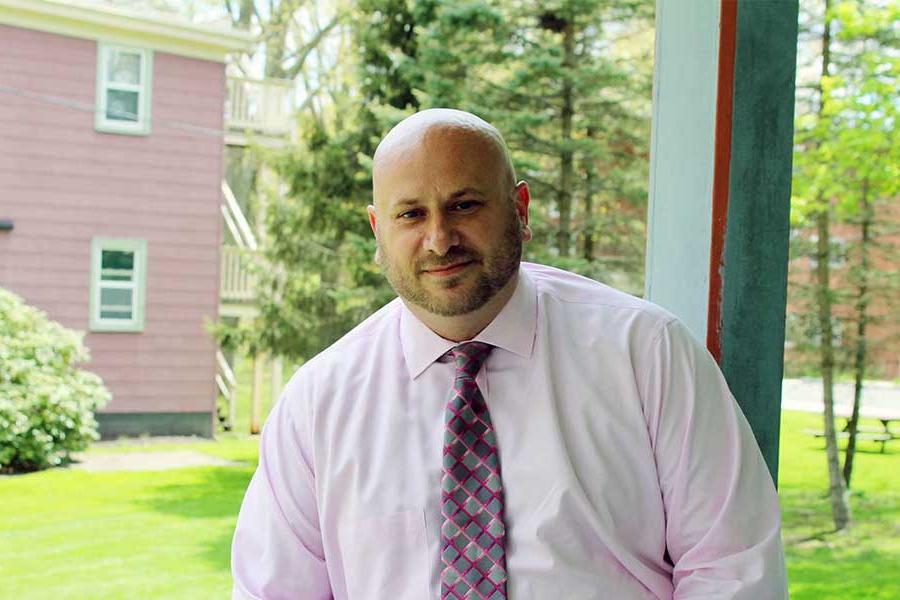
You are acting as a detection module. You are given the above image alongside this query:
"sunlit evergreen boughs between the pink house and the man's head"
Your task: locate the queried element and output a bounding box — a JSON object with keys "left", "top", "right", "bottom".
{"left": 251, "top": 122, "right": 393, "bottom": 358}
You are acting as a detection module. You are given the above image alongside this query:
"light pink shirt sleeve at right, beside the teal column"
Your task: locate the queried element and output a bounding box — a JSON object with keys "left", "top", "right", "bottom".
{"left": 644, "top": 321, "right": 787, "bottom": 600}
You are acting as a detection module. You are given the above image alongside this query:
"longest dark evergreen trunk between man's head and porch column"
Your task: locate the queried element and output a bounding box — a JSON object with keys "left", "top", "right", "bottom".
{"left": 556, "top": 18, "right": 575, "bottom": 256}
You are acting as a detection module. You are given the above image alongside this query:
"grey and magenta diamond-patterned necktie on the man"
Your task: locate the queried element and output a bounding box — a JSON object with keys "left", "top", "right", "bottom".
{"left": 441, "top": 342, "right": 507, "bottom": 600}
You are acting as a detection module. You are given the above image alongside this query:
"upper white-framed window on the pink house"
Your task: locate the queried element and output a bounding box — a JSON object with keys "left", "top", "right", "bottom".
{"left": 94, "top": 43, "right": 153, "bottom": 135}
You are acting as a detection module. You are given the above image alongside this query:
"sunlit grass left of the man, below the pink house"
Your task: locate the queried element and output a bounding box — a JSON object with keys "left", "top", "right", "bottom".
{"left": 0, "top": 437, "right": 256, "bottom": 600}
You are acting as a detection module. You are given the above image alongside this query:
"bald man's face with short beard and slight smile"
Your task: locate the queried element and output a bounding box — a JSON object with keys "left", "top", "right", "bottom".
{"left": 369, "top": 128, "right": 530, "bottom": 316}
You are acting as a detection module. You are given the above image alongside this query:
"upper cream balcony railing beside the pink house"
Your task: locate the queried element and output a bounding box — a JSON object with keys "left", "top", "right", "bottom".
{"left": 225, "top": 77, "right": 294, "bottom": 136}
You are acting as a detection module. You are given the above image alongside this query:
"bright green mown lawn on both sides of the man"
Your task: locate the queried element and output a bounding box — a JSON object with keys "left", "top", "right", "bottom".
{"left": 0, "top": 413, "right": 900, "bottom": 600}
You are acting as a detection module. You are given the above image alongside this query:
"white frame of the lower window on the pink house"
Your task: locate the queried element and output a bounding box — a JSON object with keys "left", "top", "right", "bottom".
{"left": 90, "top": 237, "right": 147, "bottom": 331}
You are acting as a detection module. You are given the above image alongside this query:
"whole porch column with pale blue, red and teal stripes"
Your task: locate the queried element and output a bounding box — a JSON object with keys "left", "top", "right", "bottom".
{"left": 646, "top": 0, "right": 798, "bottom": 481}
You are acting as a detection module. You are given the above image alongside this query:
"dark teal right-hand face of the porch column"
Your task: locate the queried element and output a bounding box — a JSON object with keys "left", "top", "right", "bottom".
{"left": 720, "top": 0, "right": 798, "bottom": 481}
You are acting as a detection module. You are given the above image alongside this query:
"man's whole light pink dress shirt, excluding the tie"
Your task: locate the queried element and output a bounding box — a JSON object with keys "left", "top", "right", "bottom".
{"left": 232, "top": 263, "right": 787, "bottom": 600}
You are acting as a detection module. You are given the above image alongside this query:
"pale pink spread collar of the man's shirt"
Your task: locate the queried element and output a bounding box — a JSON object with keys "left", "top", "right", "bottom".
{"left": 400, "top": 268, "right": 537, "bottom": 379}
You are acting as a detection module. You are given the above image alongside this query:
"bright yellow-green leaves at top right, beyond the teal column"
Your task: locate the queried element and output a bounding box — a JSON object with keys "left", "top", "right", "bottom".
{"left": 791, "top": 0, "right": 900, "bottom": 226}
